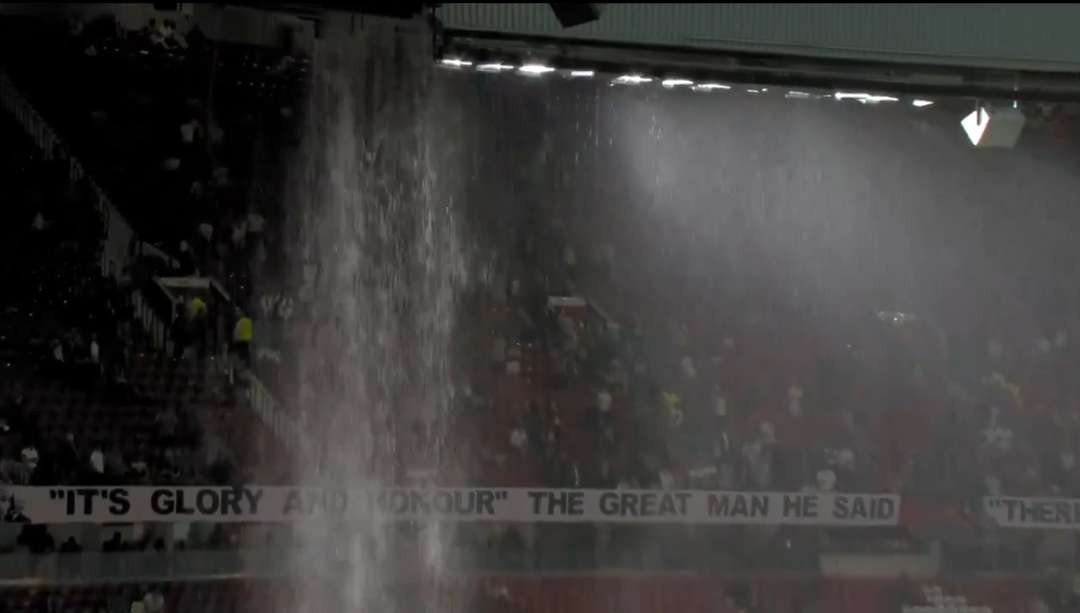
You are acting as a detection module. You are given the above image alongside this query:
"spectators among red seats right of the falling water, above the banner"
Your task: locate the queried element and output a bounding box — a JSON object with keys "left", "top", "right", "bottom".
{"left": 397, "top": 74, "right": 1080, "bottom": 516}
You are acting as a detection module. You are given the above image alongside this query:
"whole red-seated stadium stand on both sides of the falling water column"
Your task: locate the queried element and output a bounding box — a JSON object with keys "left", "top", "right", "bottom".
{"left": 0, "top": 6, "right": 1080, "bottom": 613}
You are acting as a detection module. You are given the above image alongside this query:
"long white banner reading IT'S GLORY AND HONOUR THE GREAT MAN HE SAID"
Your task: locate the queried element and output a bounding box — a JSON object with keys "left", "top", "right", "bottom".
{"left": 0, "top": 486, "right": 900, "bottom": 526}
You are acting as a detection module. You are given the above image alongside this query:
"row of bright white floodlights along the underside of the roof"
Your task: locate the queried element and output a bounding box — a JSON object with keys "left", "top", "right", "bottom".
{"left": 440, "top": 57, "right": 934, "bottom": 108}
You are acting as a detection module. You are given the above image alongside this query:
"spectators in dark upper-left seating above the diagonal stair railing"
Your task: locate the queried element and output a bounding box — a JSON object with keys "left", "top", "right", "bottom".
{"left": 10, "top": 10, "right": 307, "bottom": 364}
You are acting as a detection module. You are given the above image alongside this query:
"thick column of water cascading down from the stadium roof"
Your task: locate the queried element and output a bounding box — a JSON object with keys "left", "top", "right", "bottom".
{"left": 289, "top": 16, "right": 464, "bottom": 611}
